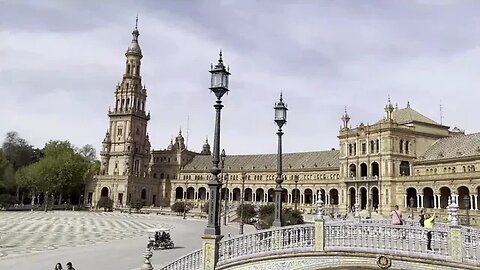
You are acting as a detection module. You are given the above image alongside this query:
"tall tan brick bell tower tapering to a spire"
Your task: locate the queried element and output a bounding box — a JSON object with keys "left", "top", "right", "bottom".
{"left": 100, "top": 17, "right": 150, "bottom": 176}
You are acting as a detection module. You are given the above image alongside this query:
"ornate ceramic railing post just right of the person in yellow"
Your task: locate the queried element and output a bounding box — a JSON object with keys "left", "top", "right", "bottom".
{"left": 448, "top": 196, "right": 463, "bottom": 262}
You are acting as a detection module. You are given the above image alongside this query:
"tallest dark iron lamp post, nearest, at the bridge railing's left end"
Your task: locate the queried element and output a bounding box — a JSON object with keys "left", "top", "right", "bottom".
{"left": 205, "top": 51, "right": 230, "bottom": 235}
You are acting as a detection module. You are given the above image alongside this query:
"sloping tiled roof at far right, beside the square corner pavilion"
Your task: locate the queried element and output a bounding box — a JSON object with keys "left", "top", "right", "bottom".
{"left": 419, "top": 133, "right": 480, "bottom": 161}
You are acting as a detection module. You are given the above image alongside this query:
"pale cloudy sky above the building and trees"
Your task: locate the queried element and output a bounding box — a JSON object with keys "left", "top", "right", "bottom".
{"left": 0, "top": 0, "right": 480, "bottom": 154}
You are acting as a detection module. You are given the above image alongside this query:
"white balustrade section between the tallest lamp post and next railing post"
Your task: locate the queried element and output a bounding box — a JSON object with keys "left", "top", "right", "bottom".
{"left": 218, "top": 224, "right": 315, "bottom": 266}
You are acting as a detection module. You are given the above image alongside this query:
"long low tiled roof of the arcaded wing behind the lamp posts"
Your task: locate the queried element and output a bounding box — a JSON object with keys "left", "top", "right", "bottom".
{"left": 184, "top": 150, "right": 340, "bottom": 171}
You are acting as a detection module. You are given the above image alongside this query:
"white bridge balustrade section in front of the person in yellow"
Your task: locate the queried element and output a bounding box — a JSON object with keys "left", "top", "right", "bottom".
{"left": 324, "top": 222, "right": 450, "bottom": 259}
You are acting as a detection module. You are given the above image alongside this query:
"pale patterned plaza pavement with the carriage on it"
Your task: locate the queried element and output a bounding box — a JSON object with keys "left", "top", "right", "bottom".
{"left": 0, "top": 211, "right": 255, "bottom": 270}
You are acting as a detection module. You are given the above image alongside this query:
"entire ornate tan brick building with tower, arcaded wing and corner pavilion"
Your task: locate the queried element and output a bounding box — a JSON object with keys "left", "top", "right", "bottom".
{"left": 85, "top": 24, "right": 480, "bottom": 223}
